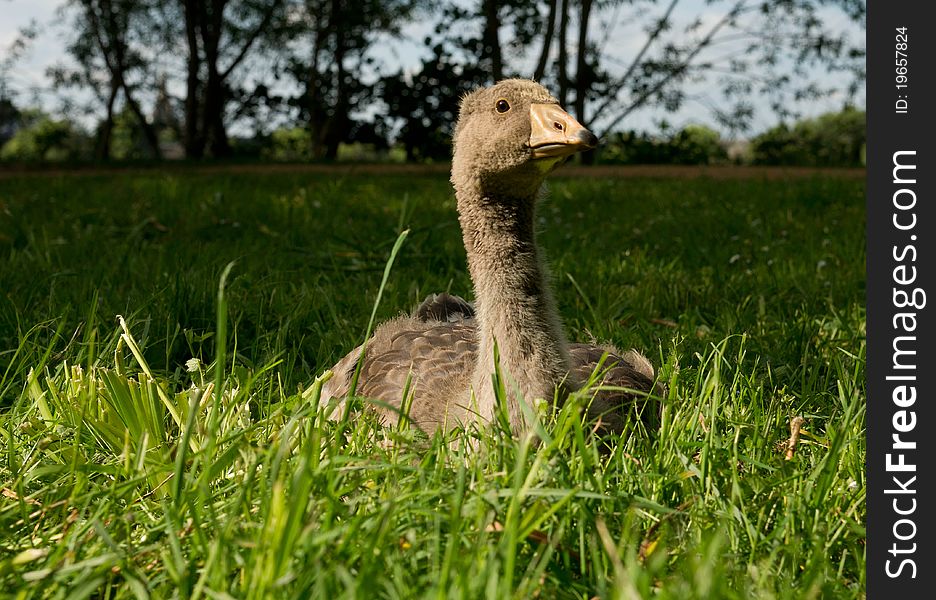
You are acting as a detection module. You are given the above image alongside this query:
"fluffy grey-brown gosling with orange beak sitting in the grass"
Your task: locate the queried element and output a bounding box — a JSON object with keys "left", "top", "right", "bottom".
{"left": 322, "top": 79, "right": 654, "bottom": 434}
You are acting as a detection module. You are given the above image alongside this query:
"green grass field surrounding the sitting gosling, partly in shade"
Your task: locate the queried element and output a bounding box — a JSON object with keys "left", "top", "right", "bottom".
{"left": 0, "top": 172, "right": 866, "bottom": 599}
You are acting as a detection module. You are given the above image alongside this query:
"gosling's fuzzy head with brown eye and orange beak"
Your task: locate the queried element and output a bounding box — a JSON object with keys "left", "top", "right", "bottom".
{"left": 452, "top": 79, "right": 598, "bottom": 196}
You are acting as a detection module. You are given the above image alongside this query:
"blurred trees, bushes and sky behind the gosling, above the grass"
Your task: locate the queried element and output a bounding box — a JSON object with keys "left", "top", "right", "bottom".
{"left": 0, "top": 0, "right": 866, "bottom": 167}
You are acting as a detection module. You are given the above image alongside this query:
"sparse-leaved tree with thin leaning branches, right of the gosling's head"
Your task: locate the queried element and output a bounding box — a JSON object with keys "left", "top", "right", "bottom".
{"left": 585, "top": 0, "right": 865, "bottom": 133}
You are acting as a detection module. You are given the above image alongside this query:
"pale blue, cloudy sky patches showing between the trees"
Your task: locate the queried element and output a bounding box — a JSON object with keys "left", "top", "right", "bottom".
{"left": 0, "top": 0, "right": 864, "bottom": 132}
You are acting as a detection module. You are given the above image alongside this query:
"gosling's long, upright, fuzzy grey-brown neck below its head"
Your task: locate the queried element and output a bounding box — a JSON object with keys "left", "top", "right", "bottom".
{"left": 456, "top": 180, "right": 569, "bottom": 431}
